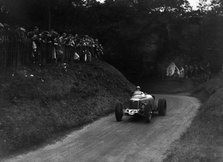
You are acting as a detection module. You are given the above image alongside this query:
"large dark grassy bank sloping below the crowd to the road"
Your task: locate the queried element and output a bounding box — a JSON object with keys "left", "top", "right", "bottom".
{"left": 0, "top": 62, "right": 133, "bottom": 157}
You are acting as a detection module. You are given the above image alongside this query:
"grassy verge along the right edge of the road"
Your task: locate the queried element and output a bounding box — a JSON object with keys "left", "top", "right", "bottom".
{"left": 164, "top": 74, "right": 223, "bottom": 162}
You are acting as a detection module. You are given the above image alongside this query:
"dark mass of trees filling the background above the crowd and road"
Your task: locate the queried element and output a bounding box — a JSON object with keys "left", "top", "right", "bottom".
{"left": 0, "top": 0, "right": 223, "bottom": 79}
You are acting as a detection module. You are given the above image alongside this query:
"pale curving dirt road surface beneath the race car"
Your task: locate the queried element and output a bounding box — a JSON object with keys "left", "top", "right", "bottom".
{"left": 5, "top": 95, "right": 200, "bottom": 162}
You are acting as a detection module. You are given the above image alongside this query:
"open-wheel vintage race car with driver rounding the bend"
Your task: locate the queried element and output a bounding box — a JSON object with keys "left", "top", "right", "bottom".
{"left": 115, "top": 86, "right": 167, "bottom": 122}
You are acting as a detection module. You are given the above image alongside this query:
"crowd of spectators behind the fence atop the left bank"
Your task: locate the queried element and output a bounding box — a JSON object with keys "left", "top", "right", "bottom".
{"left": 0, "top": 23, "right": 103, "bottom": 66}
